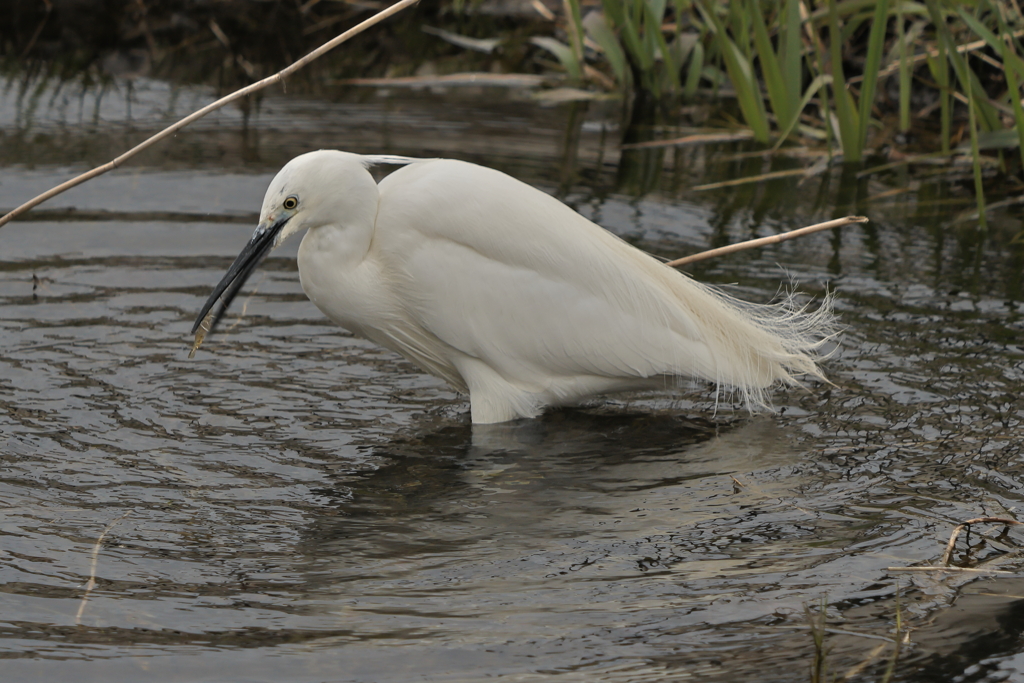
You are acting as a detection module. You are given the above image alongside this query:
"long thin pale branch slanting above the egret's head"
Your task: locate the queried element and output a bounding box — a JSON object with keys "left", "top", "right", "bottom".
{"left": 0, "top": 0, "right": 420, "bottom": 227}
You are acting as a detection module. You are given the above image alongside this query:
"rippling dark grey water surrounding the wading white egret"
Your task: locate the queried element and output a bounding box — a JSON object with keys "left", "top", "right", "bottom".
{"left": 6, "top": 70, "right": 1024, "bottom": 682}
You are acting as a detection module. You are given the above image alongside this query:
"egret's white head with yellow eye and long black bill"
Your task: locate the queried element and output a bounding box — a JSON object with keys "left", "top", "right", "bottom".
{"left": 193, "top": 150, "right": 377, "bottom": 342}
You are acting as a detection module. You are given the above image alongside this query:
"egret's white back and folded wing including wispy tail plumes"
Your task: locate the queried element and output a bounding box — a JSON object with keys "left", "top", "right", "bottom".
{"left": 370, "top": 160, "right": 830, "bottom": 420}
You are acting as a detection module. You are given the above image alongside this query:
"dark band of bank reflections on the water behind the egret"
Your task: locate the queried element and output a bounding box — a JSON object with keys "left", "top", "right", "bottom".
{"left": 0, "top": 63, "right": 1024, "bottom": 301}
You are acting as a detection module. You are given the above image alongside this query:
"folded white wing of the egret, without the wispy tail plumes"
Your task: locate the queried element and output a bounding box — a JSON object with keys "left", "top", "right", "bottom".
{"left": 374, "top": 160, "right": 718, "bottom": 389}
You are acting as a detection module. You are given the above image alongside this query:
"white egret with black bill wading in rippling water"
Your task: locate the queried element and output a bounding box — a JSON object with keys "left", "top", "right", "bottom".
{"left": 193, "top": 151, "right": 831, "bottom": 423}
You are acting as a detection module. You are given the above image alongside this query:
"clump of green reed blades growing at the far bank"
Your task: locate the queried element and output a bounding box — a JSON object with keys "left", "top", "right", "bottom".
{"left": 565, "top": 0, "right": 1024, "bottom": 168}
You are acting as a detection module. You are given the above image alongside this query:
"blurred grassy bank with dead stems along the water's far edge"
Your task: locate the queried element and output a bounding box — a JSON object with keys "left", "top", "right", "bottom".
{"left": 6, "top": 0, "right": 1024, "bottom": 192}
